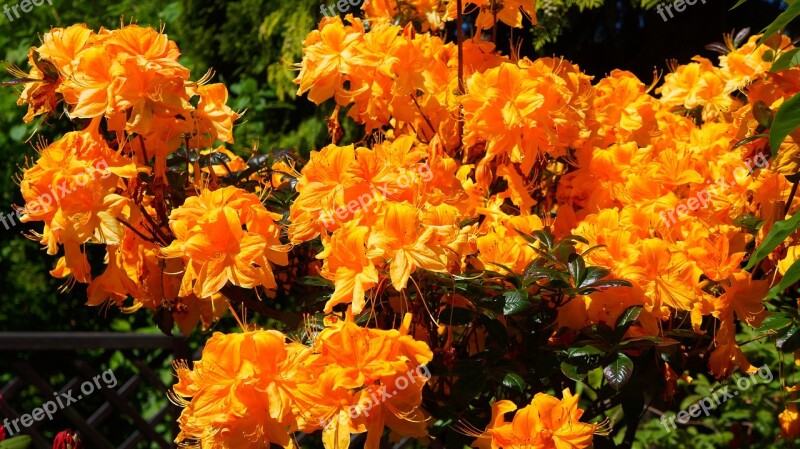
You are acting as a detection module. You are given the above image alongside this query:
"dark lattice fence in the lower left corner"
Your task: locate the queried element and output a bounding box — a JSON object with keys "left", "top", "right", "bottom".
{"left": 0, "top": 332, "right": 192, "bottom": 449}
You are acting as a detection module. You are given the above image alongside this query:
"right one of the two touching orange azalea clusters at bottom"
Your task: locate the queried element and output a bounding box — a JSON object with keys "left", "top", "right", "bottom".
{"left": 308, "top": 313, "right": 433, "bottom": 449}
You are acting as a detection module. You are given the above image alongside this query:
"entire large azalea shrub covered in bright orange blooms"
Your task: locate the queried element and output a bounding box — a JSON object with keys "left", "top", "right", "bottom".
{"left": 7, "top": 0, "right": 800, "bottom": 449}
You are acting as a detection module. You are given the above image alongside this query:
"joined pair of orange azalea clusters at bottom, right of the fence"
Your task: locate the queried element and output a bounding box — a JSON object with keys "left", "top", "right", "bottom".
{"left": 172, "top": 314, "right": 433, "bottom": 449}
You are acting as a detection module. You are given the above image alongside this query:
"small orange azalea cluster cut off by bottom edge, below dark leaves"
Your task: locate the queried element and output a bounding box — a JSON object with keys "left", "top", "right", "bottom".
{"left": 472, "top": 389, "right": 597, "bottom": 449}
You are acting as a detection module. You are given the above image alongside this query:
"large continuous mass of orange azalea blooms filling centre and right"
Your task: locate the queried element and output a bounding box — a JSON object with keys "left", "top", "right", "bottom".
{"left": 292, "top": 3, "right": 800, "bottom": 447}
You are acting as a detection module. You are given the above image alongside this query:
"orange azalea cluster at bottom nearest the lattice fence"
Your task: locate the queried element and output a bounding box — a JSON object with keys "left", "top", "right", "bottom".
{"left": 172, "top": 331, "right": 313, "bottom": 449}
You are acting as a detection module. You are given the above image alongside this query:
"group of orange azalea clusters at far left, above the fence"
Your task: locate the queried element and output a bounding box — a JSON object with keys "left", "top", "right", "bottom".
{"left": 12, "top": 25, "right": 287, "bottom": 333}
